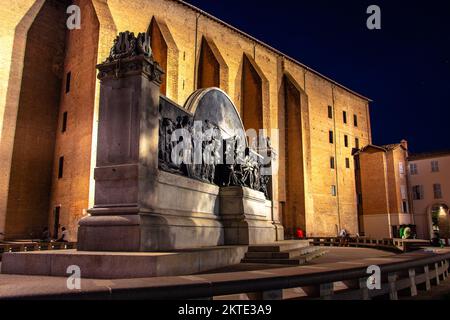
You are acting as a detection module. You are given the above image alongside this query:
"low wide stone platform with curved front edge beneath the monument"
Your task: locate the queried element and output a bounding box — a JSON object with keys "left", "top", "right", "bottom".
{"left": 1, "top": 246, "right": 248, "bottom": 279}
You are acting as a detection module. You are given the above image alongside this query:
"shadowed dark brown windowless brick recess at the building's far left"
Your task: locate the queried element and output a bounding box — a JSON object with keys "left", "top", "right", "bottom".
{"left": 5, "top": 0, "right": 66, "bottom": 238}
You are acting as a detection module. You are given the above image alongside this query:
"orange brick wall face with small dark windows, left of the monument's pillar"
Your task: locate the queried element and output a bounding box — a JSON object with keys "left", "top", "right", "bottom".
{"left": 48, "top": 0, "right": 99, "bottom": 240}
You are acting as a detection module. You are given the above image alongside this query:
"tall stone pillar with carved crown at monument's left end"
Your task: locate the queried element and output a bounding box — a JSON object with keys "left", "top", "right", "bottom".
{"left": 78, "top": 32, "right": 163, "bottom": 251}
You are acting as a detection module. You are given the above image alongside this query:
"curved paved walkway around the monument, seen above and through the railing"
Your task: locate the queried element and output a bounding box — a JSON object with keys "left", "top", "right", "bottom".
{"left": 0, "top": 247, "right": 450, "bottom": 300}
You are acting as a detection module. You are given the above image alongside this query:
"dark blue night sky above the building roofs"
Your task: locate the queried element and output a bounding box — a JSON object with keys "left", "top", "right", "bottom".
{"left": 187, "top": 0, "right": 450, "bottom": 152}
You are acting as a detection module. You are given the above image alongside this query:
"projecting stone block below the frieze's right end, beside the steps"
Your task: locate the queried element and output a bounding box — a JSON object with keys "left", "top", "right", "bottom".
{"left": 220, "top": 187, "right": 277, "bottom": 245}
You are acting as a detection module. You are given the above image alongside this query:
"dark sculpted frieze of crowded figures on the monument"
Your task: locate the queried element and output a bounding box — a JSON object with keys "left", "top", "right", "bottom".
{"left": 158, "top": 116, "right": 270, "bottom": 197}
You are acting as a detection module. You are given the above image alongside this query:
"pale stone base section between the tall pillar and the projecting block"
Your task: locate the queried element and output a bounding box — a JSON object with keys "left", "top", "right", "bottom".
{"left": 141, "top": 171, "right": 224, "bottom": 251}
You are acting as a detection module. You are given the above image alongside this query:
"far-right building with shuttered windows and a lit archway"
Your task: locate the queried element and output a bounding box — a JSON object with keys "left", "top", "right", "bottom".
{"left": 408, "top": 151, "right": 450, "bottom": 239}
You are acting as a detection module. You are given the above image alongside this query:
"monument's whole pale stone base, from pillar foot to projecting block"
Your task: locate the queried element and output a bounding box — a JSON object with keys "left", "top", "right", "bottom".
{"left": 78, "top": 171, "right": 283, "bottom": 252}
